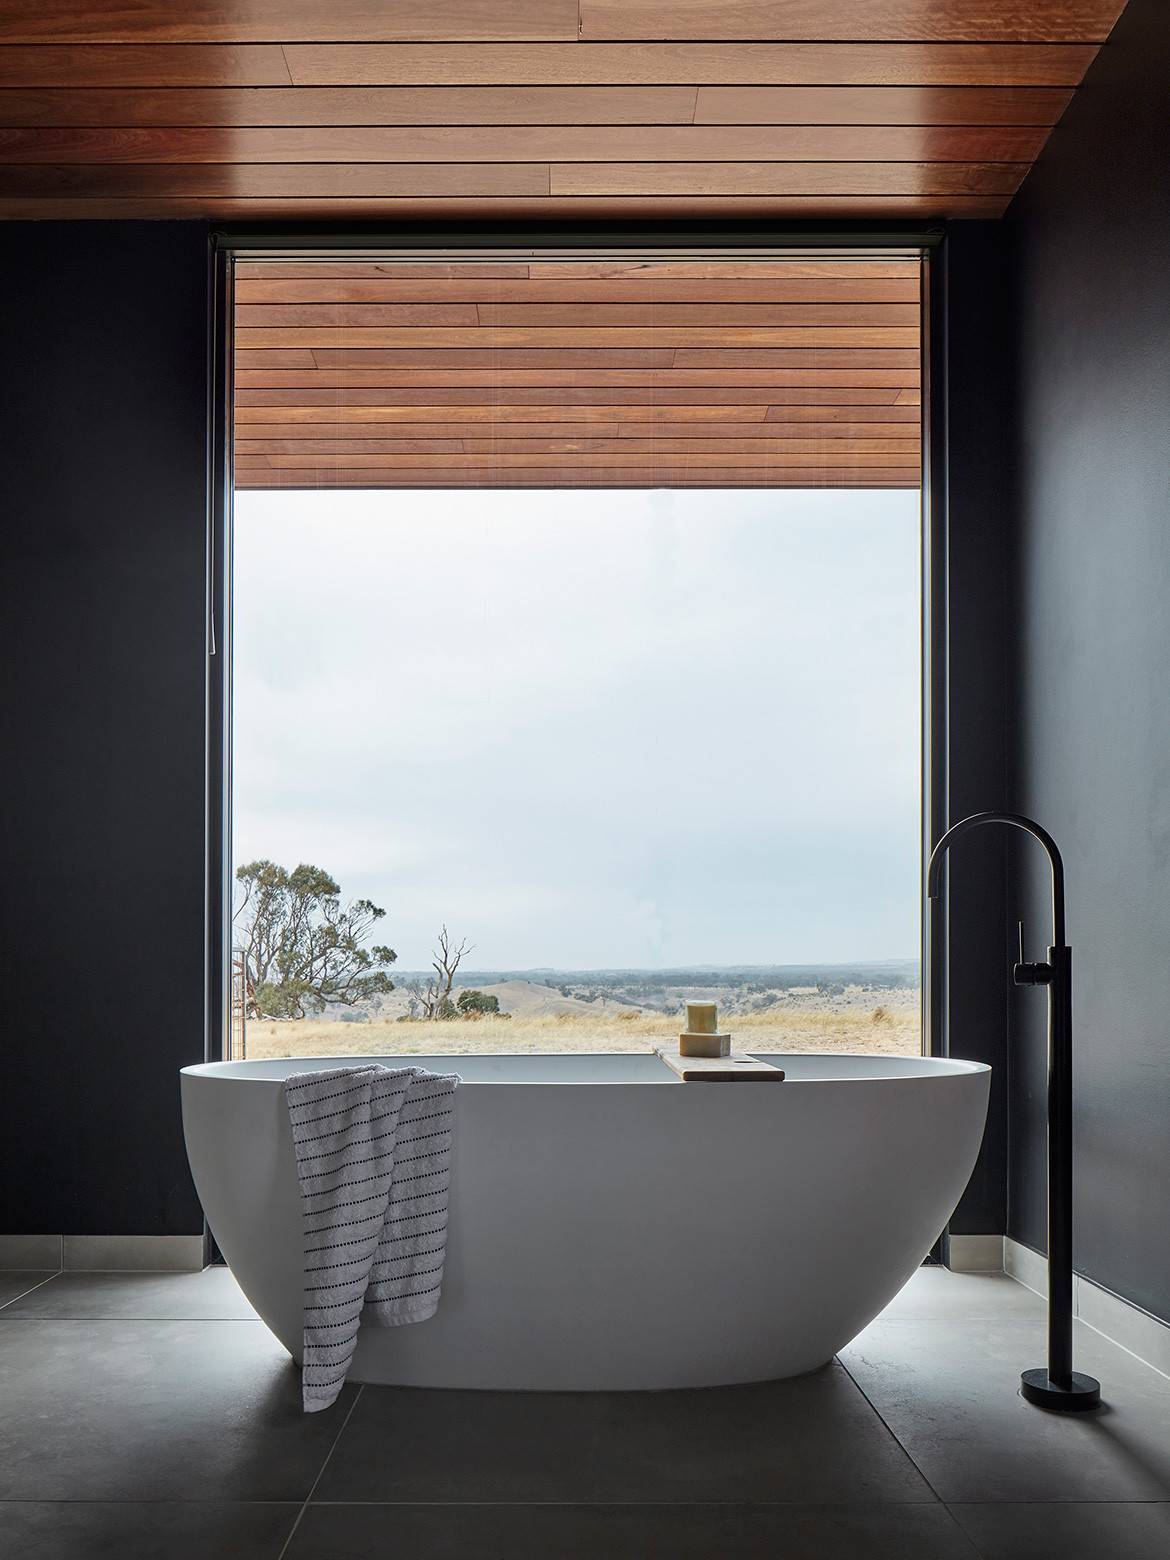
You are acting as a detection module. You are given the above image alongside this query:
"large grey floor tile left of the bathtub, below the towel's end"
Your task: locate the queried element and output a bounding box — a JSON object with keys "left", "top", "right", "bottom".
{"left": 0, "top": 1321, "right": 357, "bottom": 1501}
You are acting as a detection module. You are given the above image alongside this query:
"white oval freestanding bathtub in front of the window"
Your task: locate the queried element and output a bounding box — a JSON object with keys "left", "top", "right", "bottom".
{"left": 183, "top": 1055, "right": 991, "bottom": 1390}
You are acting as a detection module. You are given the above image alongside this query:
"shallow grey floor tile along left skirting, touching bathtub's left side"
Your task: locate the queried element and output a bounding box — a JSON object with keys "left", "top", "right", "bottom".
{"left": 3, "top": 1267, "right": 256, "bottom": 1321}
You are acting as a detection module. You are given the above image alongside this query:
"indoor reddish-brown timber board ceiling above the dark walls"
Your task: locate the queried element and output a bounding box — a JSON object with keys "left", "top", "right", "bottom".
{"left": 0, "top": 0, "right": 1122, "bottom": 220}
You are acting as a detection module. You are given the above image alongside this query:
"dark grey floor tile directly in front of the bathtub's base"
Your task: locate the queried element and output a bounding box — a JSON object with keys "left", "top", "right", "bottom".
{"left": 317, "top": 1365, "right": 934, "bottom": 1502}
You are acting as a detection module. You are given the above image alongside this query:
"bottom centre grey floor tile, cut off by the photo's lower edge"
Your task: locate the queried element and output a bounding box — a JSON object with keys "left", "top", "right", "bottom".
{"left": 287, "top": 1502, "right": 978, "bottom": 1560}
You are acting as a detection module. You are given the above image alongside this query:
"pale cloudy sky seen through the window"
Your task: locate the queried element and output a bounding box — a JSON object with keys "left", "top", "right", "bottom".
{"left": 232, "top": 490, "right": 920, "bottom": 970}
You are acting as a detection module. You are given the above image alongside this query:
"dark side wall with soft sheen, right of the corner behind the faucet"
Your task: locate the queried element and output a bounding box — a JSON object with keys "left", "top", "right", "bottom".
{"left": 1008, "top": 0, "right": 1170, "bottom": 1320}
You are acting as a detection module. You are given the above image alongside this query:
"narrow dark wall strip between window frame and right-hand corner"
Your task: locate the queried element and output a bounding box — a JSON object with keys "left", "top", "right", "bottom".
{"left": 931, "top": 222, "right": 1011, "bottom": 1234}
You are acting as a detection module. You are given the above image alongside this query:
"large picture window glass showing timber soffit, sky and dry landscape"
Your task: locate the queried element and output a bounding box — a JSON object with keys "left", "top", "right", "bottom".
{"left": 232, "top": 259, "right": 920, "bottom": 1056}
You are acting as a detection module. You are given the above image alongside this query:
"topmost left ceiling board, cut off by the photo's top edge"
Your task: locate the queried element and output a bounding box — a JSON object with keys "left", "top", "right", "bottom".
{"left": 0, "top": 0, "right": 577, "bottom": 44}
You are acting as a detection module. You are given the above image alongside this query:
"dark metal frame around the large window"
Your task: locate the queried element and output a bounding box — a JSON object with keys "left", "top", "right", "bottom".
{"left": 204, "top": 222, "right": 947, "bottom": 1061}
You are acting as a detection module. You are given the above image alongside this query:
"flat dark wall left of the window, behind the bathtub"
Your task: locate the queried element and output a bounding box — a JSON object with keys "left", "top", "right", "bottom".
{"left": 0, "top": 222, "right": 207, "bottom": 1234}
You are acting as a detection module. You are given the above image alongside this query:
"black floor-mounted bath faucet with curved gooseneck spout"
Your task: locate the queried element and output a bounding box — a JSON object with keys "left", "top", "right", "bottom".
{"left": 927, "top": 813, "right": 1101, "bottom": 1413}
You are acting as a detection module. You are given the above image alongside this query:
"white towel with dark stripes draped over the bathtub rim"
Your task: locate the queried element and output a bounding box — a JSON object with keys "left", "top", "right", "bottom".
{"left": 284, "top": 1067, "right": 459, "bottom": 1413}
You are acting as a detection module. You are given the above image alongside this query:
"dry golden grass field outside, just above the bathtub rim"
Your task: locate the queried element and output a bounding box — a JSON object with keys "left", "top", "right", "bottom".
{"left": 246, "top": 1005, "right": 922, "bottom": 1058}
